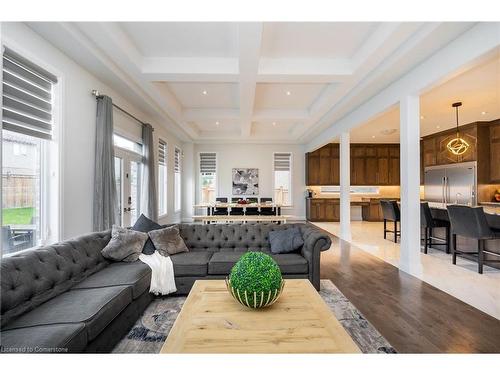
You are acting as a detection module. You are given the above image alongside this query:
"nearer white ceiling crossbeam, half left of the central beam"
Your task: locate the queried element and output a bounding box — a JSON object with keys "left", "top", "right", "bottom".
{"left": 141, "top": 57, "right": 239, "bottom": 82}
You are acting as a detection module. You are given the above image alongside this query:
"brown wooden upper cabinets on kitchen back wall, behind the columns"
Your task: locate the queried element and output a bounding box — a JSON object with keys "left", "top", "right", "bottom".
{"left": 306, "top": 143, "right": 399, "bottom": 185}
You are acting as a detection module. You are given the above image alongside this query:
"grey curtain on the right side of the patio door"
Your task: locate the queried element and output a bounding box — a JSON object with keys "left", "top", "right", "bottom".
{"left": 141, "top": 124, "right": 158, "bottom": 221}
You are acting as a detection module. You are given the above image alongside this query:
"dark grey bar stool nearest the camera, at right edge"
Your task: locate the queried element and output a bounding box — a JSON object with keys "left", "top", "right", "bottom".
{"left": 448, "top": 205, "right": 500, "bottom": 273}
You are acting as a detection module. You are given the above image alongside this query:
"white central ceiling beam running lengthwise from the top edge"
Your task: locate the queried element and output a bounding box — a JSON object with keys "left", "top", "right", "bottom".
{"left": 238, "top": 22, "right": 263, "bottom": 137}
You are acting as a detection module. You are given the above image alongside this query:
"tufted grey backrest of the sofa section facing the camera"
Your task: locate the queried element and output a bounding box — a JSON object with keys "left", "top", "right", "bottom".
{"left": 179, "top": 223, "right": 304, "bottom": 252}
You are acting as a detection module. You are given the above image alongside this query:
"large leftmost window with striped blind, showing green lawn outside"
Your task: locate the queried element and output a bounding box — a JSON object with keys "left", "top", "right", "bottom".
{"left": 1, "top": 48, "right": 58, "bottom": 255}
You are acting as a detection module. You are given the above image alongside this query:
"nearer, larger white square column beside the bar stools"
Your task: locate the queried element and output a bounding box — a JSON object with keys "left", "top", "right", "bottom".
{"left": 399, "top": 95, "right": 422, "bottom": 275}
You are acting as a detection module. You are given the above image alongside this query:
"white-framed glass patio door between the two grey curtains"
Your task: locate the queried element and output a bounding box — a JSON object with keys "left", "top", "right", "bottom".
{"left": 115, "top": 148, "right": 142, "bottom": 227}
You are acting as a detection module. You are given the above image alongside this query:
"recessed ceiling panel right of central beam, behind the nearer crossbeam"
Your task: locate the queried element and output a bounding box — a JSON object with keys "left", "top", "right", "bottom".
{"left": 255, "top": 83, "right": 326, "bottom": 110}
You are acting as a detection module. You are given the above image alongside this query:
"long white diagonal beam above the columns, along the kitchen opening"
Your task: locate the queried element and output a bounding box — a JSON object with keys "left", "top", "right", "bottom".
{"left": 306, "top": 23, "right": 500, "bottom": 151}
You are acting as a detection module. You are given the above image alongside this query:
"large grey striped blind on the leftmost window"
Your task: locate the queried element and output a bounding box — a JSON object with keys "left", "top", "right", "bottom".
{"left": 2, "top": 48, "right": 57, "bottom": 139}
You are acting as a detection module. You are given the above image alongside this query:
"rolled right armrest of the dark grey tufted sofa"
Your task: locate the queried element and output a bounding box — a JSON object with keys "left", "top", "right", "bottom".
{"left": 300, "top": 224, "right": 332, "bottom": 290}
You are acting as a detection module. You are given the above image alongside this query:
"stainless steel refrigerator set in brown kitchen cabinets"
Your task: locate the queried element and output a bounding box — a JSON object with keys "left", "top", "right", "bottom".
{"left": 424, "top": 162, "right": 477, "bottom": 206}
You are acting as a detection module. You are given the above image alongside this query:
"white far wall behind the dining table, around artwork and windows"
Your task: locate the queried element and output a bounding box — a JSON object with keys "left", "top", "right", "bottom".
{"left": 193, "top": 144, "right": 306, "bottom": 220}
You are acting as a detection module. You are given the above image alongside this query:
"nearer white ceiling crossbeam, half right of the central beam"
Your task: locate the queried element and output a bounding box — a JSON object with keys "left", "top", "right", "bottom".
{"left": 257, "top": 57, "right": 353, "bottom": 83}
